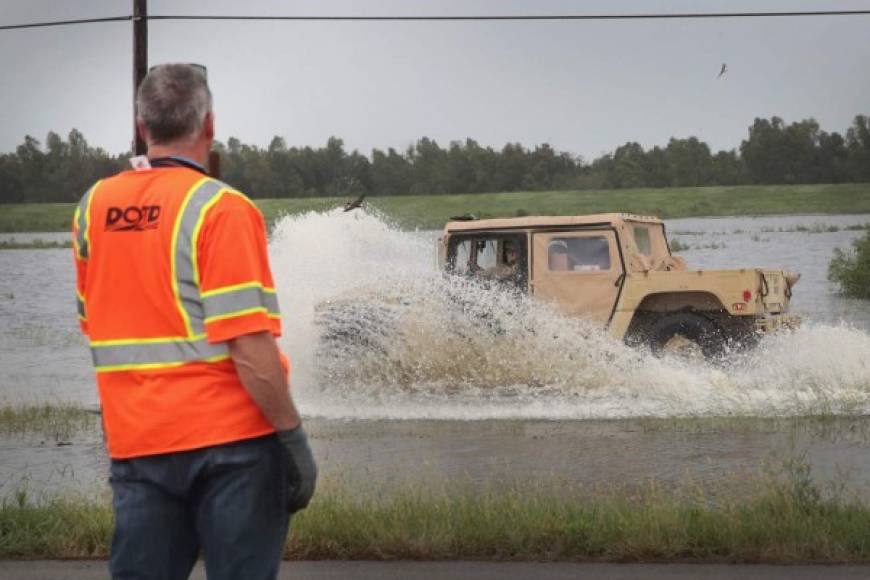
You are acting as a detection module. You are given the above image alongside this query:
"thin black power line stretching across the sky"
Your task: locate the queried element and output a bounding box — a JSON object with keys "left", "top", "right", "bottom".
{"left": 0, "top": 9, "right": 870, "bottom": 30}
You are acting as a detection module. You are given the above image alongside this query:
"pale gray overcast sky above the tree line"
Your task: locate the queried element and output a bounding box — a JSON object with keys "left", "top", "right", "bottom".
{"left": 0, "top": 0, "right": 870, "bottom": 158}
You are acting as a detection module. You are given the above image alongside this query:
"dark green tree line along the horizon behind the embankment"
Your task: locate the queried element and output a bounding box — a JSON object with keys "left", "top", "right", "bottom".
{"left": 0, "top": 115, "right": 870, "bottom": 203}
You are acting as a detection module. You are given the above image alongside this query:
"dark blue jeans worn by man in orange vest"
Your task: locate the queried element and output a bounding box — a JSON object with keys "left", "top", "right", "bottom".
{"left": 110, "top": 435, "right": 289, "bottom": 580}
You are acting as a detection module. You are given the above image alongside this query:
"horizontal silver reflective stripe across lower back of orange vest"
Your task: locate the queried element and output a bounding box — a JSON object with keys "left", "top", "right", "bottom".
{"left": 91, "top": 338, "right": 229, "bottom": 370}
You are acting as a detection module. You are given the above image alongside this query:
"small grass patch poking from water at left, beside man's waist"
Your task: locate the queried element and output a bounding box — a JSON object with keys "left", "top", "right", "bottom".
{"left": 0, "top": 403, "right": 100, "bottom": 441}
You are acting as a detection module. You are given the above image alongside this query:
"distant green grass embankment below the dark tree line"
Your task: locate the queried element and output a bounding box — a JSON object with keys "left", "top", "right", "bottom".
{"left": 0, "top": 183, "right": 870, "bottom": 232}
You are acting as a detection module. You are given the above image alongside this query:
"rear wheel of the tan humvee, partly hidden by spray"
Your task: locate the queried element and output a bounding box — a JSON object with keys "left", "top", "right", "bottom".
{"left": 648, "top": 312, "right": 725, "bottom": 360}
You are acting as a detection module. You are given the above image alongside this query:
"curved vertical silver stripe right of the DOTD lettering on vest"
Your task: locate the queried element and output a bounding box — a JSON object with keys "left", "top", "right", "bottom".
{"left": 175, "top": 179, "right": 226, "bottom": 335}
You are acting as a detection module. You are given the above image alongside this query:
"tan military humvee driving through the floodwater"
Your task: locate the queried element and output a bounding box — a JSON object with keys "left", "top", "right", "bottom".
{"left": 439, "top": 214, "right": 800, "bottom": 357}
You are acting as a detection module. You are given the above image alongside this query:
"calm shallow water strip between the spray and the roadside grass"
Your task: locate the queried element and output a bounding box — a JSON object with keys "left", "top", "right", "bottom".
{"left": 0, "top": 417, "right": 870, "bottom": 501}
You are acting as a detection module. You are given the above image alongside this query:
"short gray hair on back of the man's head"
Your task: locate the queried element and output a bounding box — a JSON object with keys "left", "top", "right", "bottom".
{"left": 136, "top": 64, "right": 211, "bottom": 145}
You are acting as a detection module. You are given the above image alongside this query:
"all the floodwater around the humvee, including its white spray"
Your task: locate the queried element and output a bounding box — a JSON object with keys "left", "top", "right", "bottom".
{"left": 0, "top": 212, "right": 870, "bottom": 495}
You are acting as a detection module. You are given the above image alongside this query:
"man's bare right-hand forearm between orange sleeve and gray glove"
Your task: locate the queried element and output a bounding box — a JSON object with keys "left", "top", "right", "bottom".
{"left": 229, "top": 331, "right": 301, "bottom": 431}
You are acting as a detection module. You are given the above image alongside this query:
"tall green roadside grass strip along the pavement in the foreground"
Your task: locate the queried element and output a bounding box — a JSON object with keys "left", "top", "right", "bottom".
{"left": 0, "top": 461, "right": 870, "bottom": 563}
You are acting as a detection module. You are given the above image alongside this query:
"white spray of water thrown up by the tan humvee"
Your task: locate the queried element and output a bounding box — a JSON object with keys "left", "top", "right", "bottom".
{"left": 271, "top": 210, "right": 870, "bottom": 419}
